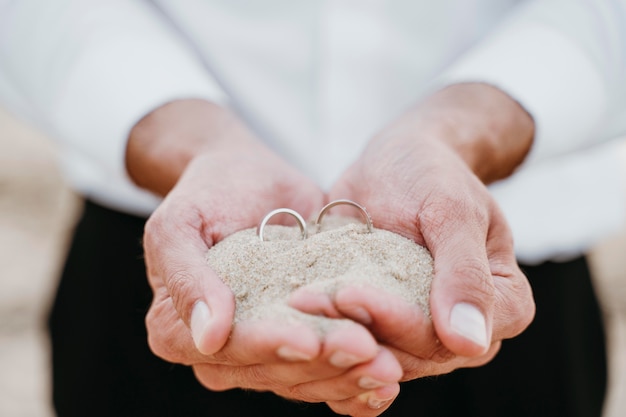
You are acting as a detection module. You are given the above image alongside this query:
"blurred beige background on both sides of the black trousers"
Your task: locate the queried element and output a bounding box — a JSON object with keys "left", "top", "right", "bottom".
{"left": 0, "top": 109, "right": 626, "bottom": 417}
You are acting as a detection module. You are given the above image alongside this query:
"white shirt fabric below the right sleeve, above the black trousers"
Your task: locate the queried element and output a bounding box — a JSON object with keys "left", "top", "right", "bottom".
{"left": 490, "top": 136, "right": 626, "bottom": 264}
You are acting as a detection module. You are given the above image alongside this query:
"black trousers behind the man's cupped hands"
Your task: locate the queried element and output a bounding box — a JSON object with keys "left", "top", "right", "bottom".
{"left": 49, "top": 202, "right": 606, "bottom": 417}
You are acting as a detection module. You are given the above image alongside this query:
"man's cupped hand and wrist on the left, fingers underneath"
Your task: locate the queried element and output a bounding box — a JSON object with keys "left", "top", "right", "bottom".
{"left": 127, "top": 100, "right": 402, "bottom": 416}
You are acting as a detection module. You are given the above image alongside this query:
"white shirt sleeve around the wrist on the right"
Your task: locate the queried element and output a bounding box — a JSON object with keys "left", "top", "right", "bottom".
{"left": 438, "top": 0, "right": 626, "bottom": 161}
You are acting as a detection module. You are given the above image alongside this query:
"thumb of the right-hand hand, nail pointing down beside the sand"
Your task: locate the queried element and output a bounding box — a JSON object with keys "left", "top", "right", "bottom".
{"left": 417, "top": 196, "right": 494, "bottom": 356}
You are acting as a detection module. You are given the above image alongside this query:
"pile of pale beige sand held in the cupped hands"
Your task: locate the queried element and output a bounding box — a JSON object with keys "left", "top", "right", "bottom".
{"left": 207, "top": 216, "right": 433, "bottom": 332}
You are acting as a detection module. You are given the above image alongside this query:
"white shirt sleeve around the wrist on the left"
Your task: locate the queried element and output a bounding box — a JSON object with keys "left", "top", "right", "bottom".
{"left": 0, "top": 0, "right": 227, "bottom": 210}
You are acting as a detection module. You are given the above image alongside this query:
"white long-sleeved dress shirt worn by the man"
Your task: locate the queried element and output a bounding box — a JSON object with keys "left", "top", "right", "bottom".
{"left": 0, "top": 0, "right": 626, "bottom": 262}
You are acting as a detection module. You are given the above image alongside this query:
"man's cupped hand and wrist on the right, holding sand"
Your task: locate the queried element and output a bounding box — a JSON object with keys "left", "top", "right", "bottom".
{"left": 291, "top": 84, "right": 534, "bottom": 379}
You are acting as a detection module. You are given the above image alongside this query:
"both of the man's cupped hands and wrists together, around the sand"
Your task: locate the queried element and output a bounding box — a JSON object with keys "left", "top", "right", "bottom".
{"left": 127, "top": 84, "right": 534, "bottom": 416}
